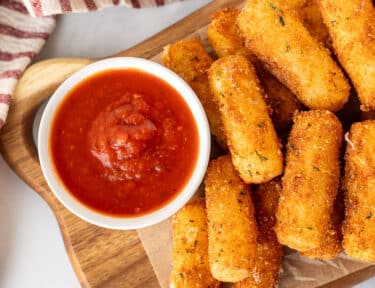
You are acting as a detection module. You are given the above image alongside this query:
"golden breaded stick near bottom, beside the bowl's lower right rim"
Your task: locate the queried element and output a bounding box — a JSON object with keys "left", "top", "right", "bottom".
{"left": 205, "top": 155, "right": 258, "bottom": 282}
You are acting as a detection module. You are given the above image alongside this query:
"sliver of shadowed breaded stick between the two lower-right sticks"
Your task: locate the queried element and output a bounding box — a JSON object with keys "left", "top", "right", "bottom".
{"left": 301, "top": 193, "right": 344, "bottom": 260}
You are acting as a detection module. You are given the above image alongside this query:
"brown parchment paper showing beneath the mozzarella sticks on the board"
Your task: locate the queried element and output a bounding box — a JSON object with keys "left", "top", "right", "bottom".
{"left": 142, "top": 22, "right": 375, "bottom": 288}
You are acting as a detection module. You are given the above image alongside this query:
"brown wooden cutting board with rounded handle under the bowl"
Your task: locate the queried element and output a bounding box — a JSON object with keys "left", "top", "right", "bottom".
{"left": 0, "top": 0, "right": 243, "bottom": 288}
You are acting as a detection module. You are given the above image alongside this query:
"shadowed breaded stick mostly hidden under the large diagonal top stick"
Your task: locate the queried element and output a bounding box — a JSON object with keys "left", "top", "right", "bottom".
{"left": 207, "top": 8, "right": 301, "bottom": 129}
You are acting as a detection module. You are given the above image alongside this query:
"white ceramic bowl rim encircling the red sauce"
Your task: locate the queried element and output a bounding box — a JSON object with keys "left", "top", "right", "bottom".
{"left": 38, "top": 57, "right": 211, "bottom": 230}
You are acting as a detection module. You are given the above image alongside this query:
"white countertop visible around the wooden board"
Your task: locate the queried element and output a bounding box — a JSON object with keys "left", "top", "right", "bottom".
{"left": 0, "top": 0, "right": 375, "bottom": 288}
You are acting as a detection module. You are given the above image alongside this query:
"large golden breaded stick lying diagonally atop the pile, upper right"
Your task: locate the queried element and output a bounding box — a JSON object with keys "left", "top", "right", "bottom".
{"left": 237, "top": 0, "right": 350, "bottom": 111}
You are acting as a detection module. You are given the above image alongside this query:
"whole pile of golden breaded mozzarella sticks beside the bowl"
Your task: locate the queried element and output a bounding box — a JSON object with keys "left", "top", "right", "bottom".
{"left": 163, "top": 0, "right": 375, "bottom": 288}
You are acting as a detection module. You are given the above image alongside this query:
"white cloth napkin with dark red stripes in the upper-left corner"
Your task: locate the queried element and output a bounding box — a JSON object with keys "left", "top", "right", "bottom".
{"left": 0, "top": 0, "right": 179, "bottom": 128}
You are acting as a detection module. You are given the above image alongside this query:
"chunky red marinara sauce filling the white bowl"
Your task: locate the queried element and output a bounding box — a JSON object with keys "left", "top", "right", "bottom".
{"left": 50, "top": 69, "right": 203, "bottom": 217}
